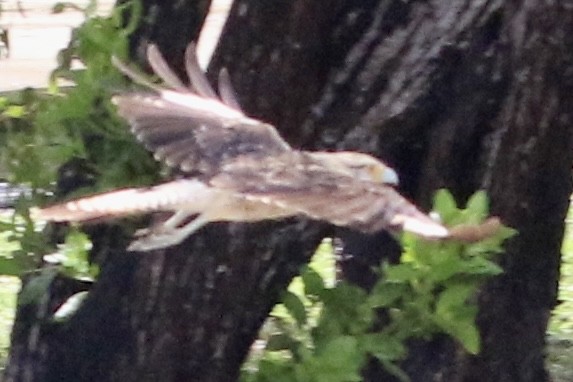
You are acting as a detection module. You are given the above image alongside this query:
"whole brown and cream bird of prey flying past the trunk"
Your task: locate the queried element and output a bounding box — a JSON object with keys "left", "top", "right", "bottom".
{"left": 35, "top": 44, "right": 449, "bottom": 251}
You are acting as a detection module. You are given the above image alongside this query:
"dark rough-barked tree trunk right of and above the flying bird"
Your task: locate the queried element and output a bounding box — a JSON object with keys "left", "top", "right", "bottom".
{"left": 216, "top": 1, "right": 573, "bottom": 381}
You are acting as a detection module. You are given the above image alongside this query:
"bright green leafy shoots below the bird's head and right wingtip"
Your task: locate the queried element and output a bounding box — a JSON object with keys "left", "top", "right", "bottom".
{"left": 242, "top": 190, "right": 515, "bottom": 382}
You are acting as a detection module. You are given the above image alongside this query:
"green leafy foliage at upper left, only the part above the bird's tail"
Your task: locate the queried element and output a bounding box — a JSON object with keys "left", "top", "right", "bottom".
{"left": 0, "top": 2, "right": 157, "bottom": 189}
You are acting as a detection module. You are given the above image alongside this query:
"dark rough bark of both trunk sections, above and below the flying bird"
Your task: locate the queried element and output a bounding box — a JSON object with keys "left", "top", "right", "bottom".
{"left": 7, "top": 0, "right": 573, "bottom": 382}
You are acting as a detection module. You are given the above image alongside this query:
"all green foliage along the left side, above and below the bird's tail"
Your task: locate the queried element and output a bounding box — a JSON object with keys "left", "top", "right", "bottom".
{"left": 0, "top": 0, "right": 153, "bottom": 302}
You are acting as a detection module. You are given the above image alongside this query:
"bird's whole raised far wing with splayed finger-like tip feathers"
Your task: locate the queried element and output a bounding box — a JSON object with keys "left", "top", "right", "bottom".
{"left": 113, "top": 44, "right": 291, "bottom": 176}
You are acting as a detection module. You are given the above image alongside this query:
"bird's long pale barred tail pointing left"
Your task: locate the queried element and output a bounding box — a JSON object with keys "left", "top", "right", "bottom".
{"left": 32, "top": 180, "right": 212, "bottom": 222}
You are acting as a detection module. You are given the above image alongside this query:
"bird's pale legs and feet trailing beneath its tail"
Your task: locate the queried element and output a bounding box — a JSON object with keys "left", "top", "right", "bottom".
{"left": 127, "top": 213, "right": 209, "bottom": 252}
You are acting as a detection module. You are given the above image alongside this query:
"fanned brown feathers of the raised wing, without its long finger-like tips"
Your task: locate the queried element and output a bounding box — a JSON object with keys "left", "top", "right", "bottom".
{"left": 114, "top": 95, "right": 291, "bottom": 176}
